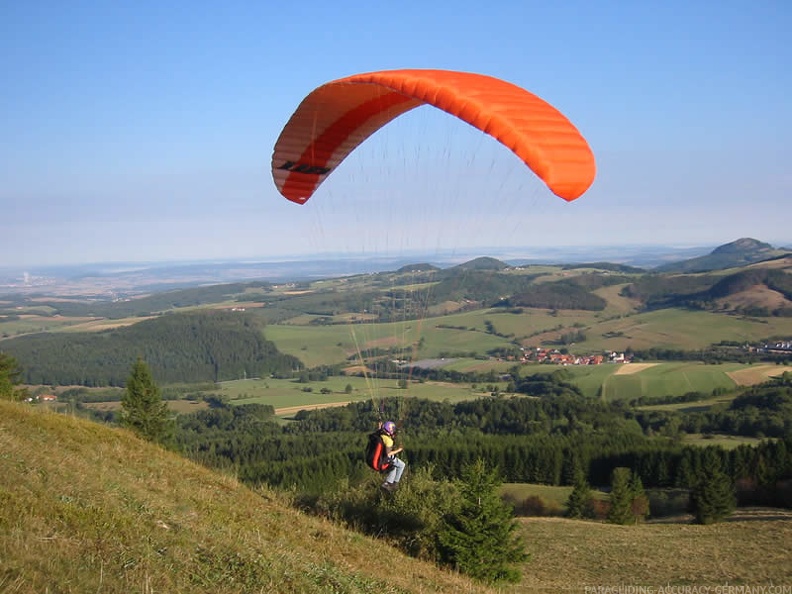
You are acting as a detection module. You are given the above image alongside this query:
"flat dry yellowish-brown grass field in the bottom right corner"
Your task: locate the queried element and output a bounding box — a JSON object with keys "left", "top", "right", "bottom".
{"left": 513, "top": 513, "right": 792, "bottom": 592}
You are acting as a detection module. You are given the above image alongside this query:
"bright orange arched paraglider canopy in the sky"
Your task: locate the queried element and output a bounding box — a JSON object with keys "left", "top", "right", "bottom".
{"left": 272, "top": 70, "right": 596, "bottom": 204}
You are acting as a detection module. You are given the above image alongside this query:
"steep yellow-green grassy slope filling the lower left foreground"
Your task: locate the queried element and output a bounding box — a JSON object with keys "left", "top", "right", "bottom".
{"left": 0, "top": 401, "right": 483, "bottom": 594}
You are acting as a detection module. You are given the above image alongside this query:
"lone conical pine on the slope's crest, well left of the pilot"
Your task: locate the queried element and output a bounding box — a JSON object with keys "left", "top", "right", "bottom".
{"left": 121, "top": 358, "right": 172, "bottom": 443}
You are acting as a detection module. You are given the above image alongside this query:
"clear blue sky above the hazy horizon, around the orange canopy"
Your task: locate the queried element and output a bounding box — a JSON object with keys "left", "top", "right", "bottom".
{"left": 0, "top": 0, "right": 792, "bottom": 267}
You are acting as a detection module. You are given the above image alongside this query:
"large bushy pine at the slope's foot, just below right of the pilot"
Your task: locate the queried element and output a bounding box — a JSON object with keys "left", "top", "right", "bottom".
{"left": 438, "top": 460, "right": 527, "bottom": 583}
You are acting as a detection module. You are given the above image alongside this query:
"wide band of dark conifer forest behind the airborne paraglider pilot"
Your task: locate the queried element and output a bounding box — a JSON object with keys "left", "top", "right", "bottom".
{"left": 167, "top": 372, "right": 792, "bottom": 506}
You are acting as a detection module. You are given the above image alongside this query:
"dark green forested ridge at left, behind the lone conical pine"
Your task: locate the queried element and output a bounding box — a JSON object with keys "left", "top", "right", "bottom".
{"left": 4, "top": 311, "right": 302, "bottom": 387}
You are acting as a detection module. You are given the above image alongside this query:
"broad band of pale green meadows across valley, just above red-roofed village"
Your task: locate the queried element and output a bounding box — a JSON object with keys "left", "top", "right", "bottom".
{"left": 265, "top": 308, "right": 792, "bottom": 367}
